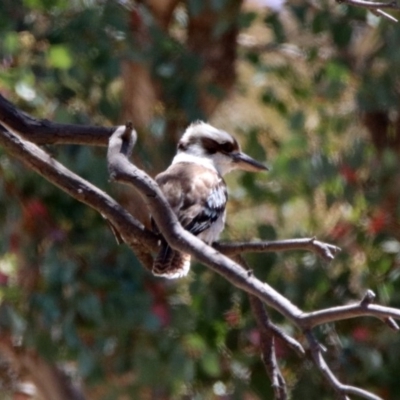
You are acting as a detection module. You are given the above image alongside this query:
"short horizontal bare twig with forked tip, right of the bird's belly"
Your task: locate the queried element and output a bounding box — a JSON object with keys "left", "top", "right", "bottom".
{"left": 213, "top": 238, "right": 340, "bottom": 261}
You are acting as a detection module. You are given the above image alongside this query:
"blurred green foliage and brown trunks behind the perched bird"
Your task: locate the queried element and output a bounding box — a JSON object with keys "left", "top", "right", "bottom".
{"left": 0, "top": 0, "right": 400, "bottom": 400}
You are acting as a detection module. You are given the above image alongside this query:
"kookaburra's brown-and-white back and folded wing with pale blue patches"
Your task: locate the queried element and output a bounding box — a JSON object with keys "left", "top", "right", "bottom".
{"left": 156, "top": 163, "right": 228, "bottom": 235}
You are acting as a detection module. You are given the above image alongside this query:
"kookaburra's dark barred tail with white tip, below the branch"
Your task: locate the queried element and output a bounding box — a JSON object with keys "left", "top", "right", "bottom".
{"left": 153, "top": 241, "right": 190, "bottom": 279}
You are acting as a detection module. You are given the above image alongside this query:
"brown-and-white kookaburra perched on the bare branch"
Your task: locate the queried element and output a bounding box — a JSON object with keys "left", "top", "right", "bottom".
{"left": 153, "top": 122, "right": 267, "bottom": 279}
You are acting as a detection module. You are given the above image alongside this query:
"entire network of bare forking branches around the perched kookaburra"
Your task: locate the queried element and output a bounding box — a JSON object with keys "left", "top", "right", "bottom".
{"left": 0, "top": 96, "right": 400, "bottom": 400}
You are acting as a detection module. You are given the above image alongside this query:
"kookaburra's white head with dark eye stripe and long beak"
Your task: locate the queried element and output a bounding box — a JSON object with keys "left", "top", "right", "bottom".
{"left": 178, "top": 121, "right": 268, "bottom": 175}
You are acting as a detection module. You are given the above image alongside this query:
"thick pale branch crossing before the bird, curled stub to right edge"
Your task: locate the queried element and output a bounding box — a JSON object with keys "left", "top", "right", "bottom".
{"left": 108, "top": 128, "right": 400, "bottom": 329}
